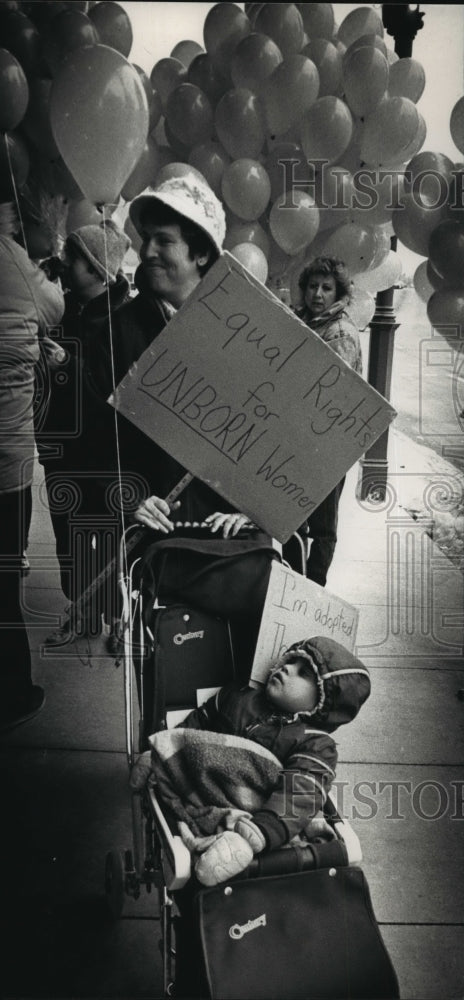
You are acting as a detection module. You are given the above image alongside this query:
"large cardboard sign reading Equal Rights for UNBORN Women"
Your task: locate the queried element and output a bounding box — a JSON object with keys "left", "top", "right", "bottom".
{"left": 110, "top": 253, "right": 395, "bottom": 541}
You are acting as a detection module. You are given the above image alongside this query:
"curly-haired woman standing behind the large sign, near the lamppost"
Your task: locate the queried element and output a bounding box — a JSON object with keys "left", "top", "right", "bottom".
{"left": 296, "top": 257, "right": 362, "bottom": 587}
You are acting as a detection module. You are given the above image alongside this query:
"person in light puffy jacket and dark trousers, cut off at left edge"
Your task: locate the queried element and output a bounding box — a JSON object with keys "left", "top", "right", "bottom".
{"left": 0, "top": 203, "right": 64, "bottom": 731}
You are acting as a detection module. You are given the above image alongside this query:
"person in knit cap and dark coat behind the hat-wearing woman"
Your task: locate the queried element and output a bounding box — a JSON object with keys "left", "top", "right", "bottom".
{"left": 36, "top": 220, "right": 130, "bottom": 646}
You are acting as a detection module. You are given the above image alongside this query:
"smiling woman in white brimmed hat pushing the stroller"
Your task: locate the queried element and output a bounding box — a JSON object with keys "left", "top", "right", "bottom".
{"left": 87, "top": 173, "right": 258, "bottom": 652}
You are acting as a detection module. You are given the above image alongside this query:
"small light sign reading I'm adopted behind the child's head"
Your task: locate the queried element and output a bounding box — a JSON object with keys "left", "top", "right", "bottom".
{"left": 251, "top": 562, "right": 359, "bottom": 684}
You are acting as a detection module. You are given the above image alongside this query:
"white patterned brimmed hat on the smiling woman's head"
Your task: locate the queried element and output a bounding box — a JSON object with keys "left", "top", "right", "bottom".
{"left": 129, "top": 173, "right": 226, "bottom": 253}
